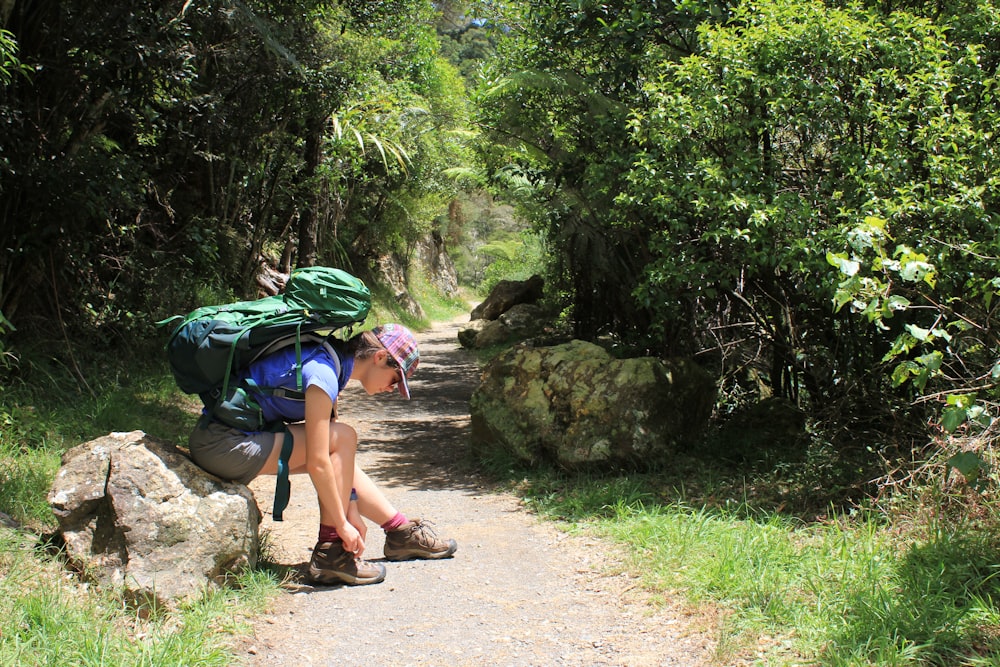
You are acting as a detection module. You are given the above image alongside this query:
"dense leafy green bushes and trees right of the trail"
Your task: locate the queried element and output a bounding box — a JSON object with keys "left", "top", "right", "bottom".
{"left": 477, "top": 0, "right": 1000, "bottom": 482}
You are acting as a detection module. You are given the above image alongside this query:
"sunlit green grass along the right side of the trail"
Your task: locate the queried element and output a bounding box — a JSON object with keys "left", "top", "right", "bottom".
{"left": 504, "top": 468, "right": 1000, "bottom": 667}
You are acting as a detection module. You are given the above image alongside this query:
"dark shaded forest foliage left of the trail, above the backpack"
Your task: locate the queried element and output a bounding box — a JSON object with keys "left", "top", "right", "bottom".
{"left": 0, "top": 0, "right": 480, "bottom": 350}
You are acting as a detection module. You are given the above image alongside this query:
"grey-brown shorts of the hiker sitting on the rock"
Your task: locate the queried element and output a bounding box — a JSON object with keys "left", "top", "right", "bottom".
{"left": 188, "top": 418, "right": 277, "bottom": 484}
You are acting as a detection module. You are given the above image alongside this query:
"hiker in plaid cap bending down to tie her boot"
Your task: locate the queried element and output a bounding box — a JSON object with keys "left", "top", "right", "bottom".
{"left": 189, "top": 324, "right": 458, "bottom": 585}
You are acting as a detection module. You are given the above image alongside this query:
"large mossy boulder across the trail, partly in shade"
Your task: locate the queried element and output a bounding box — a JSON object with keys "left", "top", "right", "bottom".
{"left": 470, "top": 340, "right": 716, "bottom": 469}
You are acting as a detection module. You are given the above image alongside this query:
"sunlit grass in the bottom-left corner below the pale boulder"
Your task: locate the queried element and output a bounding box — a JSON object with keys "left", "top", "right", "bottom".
{"left": 0, "top": 529, "right": 274, "bottom": 667}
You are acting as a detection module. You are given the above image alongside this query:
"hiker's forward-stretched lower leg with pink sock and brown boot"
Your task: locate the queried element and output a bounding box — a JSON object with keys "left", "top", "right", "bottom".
{"left": 354, "top": 465, "right": 458, "bottom": 560}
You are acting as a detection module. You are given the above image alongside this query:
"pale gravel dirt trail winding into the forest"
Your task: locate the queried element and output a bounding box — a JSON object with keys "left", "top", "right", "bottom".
{"left": 240, "top": 322, "right": 713, "bottom": 667}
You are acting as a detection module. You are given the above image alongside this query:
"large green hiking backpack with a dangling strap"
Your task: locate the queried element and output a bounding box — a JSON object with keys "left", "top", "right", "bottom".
{"left": 160, "top": 266, "right": 371, "bottom": 521}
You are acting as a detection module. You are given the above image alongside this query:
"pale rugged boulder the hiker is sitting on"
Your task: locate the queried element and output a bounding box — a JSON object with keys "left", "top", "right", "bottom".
{"left": 48, "top": 431, "right": 261, "bottom": 606}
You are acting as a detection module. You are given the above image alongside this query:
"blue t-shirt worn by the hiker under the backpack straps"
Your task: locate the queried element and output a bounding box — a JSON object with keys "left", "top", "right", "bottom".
{"left": 240, "top": 344, "right": 354, "bottom": 422}
